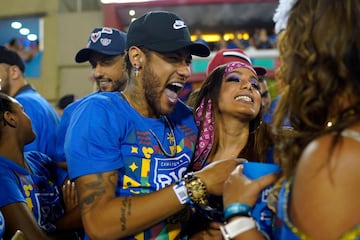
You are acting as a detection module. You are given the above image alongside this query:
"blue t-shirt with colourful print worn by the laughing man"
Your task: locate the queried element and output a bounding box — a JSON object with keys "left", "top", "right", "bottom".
{"left": 65, "top": 92, "right": 197, "bottom": 239}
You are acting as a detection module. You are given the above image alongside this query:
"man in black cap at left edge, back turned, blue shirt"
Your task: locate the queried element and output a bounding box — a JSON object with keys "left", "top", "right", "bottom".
{"left": 0, "top": 46, "right": 59, "bottom": 157}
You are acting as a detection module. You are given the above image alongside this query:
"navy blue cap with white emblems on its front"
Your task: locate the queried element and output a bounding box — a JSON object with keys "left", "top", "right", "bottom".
{"left": 75, "top": 27, "right": 126, "bottom": 63}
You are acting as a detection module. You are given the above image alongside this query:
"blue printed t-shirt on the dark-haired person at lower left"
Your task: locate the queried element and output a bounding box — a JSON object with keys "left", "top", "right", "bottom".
{"left": 0, "top": 151, "right": 67, "bottom": 232}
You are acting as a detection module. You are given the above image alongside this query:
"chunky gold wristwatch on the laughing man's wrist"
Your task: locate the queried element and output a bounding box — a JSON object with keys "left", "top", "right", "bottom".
{"left": 184, "top": 172, "right": 208, "bottom": 205}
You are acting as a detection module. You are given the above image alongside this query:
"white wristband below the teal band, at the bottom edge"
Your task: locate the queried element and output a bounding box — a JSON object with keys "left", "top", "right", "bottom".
{"left": 220, "top": 217, "right": 256, "bottom": 240}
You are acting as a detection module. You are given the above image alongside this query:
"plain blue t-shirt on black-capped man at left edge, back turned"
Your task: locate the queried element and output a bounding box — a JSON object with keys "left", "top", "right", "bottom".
{"left": 15, "top": 85, "right": 60, "bottom": 158}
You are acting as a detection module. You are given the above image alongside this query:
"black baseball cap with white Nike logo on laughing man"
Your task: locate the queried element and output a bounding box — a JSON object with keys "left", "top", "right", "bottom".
{"left": 126, "top": 11, "right": 210, "bottom": 57}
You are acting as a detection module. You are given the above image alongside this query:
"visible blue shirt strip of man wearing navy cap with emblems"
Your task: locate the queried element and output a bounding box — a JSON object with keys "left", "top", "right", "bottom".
{"left": 54, "top": 91, "right": 98, "bottom": 162}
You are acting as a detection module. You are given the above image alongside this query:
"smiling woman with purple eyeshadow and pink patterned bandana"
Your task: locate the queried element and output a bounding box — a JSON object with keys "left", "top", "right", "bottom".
{"left": 190, "top": 59, "right": 272, "bottom": 240}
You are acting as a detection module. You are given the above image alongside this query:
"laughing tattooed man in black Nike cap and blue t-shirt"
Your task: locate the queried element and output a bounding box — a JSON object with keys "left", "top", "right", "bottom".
{"left": 65, "top": 11, "right": 237, "bottom": 239}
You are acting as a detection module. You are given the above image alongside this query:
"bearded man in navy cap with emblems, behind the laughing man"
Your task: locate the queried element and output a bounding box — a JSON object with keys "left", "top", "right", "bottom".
{"left": 55, "top": 27, "right": 128, "bottom": 168}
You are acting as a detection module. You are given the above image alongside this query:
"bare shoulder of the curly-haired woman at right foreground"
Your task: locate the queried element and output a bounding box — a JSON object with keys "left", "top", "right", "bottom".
{"left": 290, "top": 128, "right": 360, "bottom": 239}
